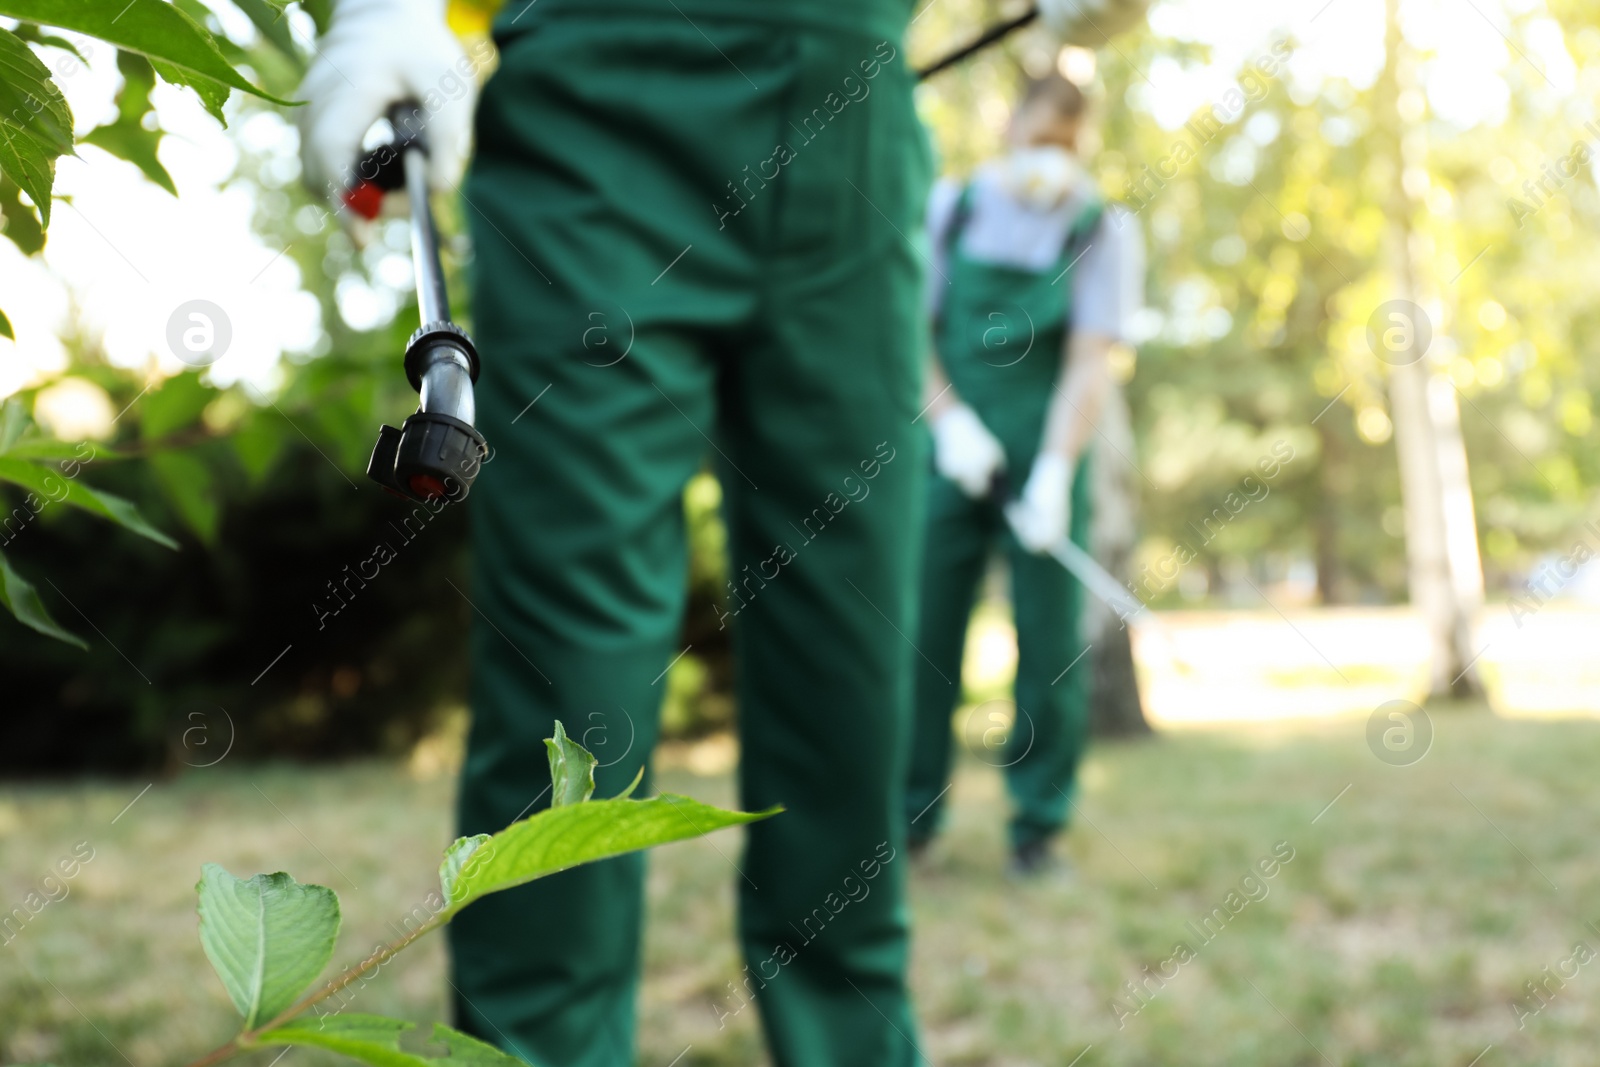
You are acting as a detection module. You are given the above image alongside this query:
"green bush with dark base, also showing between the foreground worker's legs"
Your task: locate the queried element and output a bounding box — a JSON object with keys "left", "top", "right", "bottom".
{"left": 0, "top": 379, "right": 733, "bottom": 773}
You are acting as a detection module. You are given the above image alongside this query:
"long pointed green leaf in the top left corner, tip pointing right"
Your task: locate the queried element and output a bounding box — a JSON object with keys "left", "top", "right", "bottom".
{"left": 0, "top": 0, "right": 293, "bottom": 112}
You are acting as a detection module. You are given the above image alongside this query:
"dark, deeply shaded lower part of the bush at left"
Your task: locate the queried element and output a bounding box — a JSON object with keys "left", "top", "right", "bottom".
{"left": 0, "top": 422, "right": 470, "bottom": 773}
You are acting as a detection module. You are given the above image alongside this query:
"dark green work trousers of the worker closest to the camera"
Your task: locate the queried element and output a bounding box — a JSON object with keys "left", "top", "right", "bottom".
{"left": 450, "top": 10, "right": 930, "bottom": 1067}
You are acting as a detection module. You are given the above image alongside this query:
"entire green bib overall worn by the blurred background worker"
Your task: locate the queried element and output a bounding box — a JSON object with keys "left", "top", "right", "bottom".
{"left": 906, "top": 187, "right": 1101, "bottom": 845}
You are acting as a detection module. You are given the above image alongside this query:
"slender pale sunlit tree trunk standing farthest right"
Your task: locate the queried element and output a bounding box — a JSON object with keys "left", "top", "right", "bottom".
{"left": 1370, "top": 0, "right": 1483, "bottom": 696}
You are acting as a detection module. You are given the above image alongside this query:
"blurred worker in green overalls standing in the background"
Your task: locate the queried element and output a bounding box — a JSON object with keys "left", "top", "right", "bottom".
{"left": 906, "top": 74, "right": 1142, "bottom": 875}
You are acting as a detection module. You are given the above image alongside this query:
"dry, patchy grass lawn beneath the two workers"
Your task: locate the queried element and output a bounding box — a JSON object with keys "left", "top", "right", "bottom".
{"left": 0, "top": 707, "right": 1600, "bottom": 1067}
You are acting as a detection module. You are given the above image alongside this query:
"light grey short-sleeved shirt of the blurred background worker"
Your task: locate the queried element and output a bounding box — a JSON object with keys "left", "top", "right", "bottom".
{"left": 928, "top": 170, "right": 1144, "bottom": 342}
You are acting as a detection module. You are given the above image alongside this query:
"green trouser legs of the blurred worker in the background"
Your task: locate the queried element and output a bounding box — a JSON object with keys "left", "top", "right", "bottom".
{"left": 906, "top": 453, "right": 1093, "bottom": 846}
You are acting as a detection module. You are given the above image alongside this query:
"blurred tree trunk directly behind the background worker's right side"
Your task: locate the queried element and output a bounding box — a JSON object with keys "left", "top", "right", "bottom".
{"left": 1083, "top": 386, "right": 1150, "bottom": 737}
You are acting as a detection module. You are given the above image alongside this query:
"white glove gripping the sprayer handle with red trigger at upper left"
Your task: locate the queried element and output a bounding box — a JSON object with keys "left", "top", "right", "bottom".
{"left": 298, "top": 0, "right": 478, "bottom": 206}
